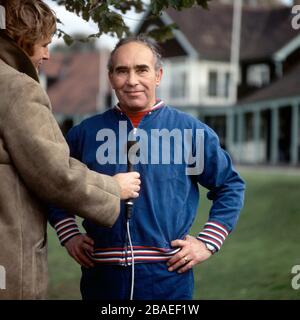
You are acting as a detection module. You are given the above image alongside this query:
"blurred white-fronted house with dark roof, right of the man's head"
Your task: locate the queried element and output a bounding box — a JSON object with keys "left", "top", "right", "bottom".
{"left": 136, "top": 2, "right": 300, "bottom": 165}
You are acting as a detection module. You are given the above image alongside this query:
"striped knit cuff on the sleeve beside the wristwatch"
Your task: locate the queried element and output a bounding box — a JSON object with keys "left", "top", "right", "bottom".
{"left": 197, "top": 221, "right": 229, "bottom": 251}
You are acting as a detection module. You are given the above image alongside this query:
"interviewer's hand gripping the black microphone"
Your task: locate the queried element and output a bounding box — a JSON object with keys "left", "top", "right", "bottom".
{"left": 113, "top": 172, "right": 141, "bottom": 200}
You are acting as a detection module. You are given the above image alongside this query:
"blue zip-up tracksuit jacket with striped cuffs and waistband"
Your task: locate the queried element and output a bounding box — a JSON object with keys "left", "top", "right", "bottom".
{"left": 49, "top": 102, "right": 245, "bottom": 265}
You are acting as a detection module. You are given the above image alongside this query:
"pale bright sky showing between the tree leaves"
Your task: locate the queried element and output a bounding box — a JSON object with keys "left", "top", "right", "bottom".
{"left": 45, "top": 0, "right": 292, "bottom": 49}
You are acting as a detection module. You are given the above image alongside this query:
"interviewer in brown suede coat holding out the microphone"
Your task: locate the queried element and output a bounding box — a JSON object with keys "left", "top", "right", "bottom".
{"left": 0, "top": 0, "right": 140, "bottom": 299}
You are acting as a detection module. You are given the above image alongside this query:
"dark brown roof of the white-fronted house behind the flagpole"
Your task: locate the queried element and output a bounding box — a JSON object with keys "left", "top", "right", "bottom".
{"left": 167, "top": 3, "right": 299, "bottom": 61}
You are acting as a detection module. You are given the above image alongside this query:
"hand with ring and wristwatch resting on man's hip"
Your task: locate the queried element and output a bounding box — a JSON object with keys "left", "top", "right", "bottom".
{"left": 167, "top": 235, "right": 212, "bottom": 273}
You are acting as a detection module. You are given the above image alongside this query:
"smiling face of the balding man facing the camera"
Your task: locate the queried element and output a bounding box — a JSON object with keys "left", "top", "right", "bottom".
{"left": 109, "top": 42, "right": 162, "bottom": 112}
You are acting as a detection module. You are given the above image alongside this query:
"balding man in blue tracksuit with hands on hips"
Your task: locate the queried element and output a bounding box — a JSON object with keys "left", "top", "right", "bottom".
{"left": 49, "top": 38, "right": 245, "bottom": 300}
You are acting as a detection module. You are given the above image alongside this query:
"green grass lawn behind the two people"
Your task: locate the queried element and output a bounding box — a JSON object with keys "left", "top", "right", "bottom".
{"left": 49, "top": 169, "right": 300, "bottom": 299}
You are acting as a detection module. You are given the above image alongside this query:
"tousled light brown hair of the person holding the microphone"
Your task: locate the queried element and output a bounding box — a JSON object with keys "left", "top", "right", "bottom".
{"left": 1, "top": 0, "right": 56, "bottom": 56}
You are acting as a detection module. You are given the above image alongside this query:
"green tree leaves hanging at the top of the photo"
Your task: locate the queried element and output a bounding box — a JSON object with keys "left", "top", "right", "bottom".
{"left": 52, "top": 0, "right": 210, "bottom": 44}
